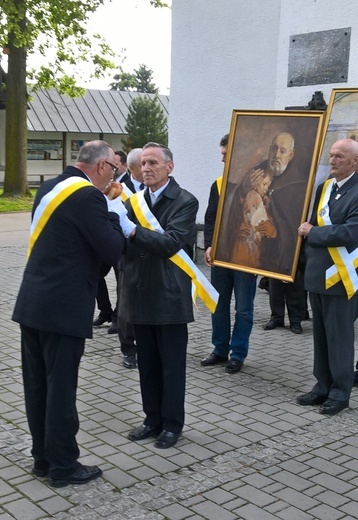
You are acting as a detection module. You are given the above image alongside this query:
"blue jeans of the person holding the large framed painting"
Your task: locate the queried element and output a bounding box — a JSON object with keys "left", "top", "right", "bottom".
{"left": 211, "top": 267, "right": 256, "bottom": 361}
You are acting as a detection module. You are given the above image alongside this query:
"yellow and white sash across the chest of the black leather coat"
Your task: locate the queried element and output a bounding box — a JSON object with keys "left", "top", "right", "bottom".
{"left": 130, "top": 190, "right": 219, "bottom": 313}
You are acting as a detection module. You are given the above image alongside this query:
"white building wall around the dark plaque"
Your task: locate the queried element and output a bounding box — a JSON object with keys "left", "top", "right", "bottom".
{"left": 169, "top": 0, "right": 358, "bottom": 223}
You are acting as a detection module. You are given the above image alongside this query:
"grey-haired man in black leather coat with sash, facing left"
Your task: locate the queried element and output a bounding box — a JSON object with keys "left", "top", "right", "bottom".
{"left": 119, "top": 143, "right": 198, "bottom": 448}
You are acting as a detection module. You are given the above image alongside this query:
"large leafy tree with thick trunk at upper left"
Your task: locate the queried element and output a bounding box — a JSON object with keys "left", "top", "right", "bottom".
{"left": 0, "top": 0, "right": 166, "bottom": 196}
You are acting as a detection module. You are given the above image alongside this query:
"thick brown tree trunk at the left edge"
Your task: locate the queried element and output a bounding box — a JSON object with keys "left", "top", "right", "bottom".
{"left": 4, "top": 21, "right": 30, "bottom": 197}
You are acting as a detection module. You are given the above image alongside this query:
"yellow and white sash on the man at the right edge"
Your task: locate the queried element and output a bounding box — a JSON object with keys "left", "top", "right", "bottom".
{"left": 317, "top": 179, "right": 358, "bottom": 300}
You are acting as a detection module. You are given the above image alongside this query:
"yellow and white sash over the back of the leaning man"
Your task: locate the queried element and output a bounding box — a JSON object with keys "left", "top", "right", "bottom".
{"left": 27, "top": 176, "right": 93, "bottom": 258}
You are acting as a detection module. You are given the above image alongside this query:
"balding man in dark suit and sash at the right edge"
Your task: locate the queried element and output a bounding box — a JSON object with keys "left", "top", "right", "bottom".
{"left": 297, "top": 139, "right": 358, "bottom": 415}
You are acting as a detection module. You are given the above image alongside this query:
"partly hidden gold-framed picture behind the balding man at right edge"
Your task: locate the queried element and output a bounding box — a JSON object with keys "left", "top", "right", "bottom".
{"left": 313, "top": 88, "right": 358, "bottom": 196}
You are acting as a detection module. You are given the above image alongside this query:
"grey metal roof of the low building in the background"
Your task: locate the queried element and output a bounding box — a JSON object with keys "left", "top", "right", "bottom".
{"left": 27, "top": 89, "right": 169, "bottom": 134}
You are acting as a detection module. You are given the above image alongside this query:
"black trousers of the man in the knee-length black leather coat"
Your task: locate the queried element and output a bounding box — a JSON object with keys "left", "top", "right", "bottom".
{"left": 134, "top": 324, "right": 188, "bottom": 433}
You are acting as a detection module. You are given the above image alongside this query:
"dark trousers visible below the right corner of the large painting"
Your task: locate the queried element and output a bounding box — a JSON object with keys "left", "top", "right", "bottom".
{"left": 269, "top": 275, "right": 307, "bottom": 325}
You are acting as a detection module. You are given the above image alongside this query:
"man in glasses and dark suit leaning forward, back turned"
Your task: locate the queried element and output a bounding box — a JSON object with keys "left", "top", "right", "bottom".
{"left": 13, "top": 141, "right": 125, "bottom": 487}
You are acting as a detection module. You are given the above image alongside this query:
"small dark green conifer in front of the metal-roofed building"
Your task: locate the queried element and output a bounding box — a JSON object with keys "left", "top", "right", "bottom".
{"left": 124, "top": 96, "right": 168, "bottom": 152}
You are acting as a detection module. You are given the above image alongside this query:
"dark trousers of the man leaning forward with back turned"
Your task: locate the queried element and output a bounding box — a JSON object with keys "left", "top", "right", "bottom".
{"left": 21, "top": 325, "right": 85, "bottom": 478}
